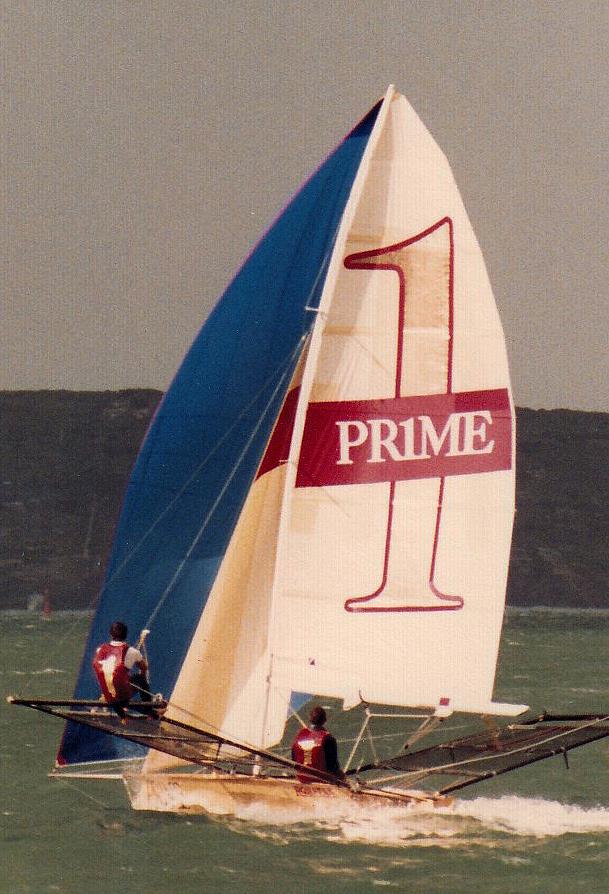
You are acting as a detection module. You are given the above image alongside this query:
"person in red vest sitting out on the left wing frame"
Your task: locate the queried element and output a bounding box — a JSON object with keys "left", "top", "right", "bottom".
{"left": 93, "top": 621, "right": 156, "bottom": 723}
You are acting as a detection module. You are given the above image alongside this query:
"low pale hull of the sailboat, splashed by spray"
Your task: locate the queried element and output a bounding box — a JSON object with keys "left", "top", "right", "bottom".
{"left": 123, "top": 773, "right": 449, "bottom": 815}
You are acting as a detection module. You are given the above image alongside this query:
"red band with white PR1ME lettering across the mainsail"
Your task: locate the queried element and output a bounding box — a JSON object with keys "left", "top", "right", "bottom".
{"left": 296, "top": 388, "right": 512, "bottom": 487}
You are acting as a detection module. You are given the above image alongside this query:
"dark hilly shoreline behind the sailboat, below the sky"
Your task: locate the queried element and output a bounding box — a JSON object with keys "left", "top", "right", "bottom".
{"left": 0, "top": 390, "right": 609, "bottom": 608}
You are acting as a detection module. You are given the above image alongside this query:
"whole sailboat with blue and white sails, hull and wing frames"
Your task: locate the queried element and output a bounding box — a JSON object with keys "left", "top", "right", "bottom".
{"left": 12, "top": 86, "right": 609, "bottom": 813}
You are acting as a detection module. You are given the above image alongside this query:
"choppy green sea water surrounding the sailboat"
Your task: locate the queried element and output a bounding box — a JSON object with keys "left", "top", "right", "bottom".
{"left": 0, "top": 612, "right": 609, "bottom": 894}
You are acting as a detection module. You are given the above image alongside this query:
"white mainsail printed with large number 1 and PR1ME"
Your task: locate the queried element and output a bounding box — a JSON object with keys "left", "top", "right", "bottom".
{"left": 264, "top": 91, "right": 514, "bottom": 724}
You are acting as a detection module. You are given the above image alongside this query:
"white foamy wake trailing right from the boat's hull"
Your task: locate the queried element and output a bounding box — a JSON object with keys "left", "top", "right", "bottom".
{"left": 223, "top": 795, "right": 609, "bottom": 848}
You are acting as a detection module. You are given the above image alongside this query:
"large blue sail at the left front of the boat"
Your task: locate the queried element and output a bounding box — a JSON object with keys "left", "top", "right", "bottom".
{"left": 58, "top": 100, "right": 378, "bottom": 763}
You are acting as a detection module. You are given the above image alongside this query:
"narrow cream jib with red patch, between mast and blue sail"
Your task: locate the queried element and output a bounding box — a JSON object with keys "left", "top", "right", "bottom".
{"left": 142, "top": 91, "right": 390, "bottom": 770}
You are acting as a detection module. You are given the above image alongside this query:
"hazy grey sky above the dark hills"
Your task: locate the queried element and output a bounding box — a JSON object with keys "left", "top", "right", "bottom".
{"left": 5, "top": 0, "right": 609, "bottom": 411}
